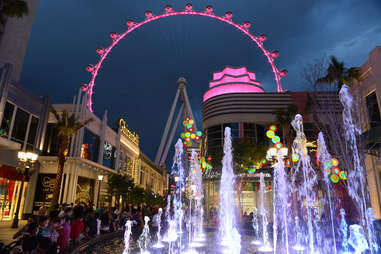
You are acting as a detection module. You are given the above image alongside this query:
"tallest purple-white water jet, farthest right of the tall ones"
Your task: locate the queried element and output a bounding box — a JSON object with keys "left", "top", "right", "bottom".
{"left": 340, "top": 85, "right": 378, "bottom": 254}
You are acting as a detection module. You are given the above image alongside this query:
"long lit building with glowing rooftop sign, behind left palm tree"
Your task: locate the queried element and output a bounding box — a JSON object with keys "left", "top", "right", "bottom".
{"left": 34, "top": 92, "right": 166, "bottom": 210}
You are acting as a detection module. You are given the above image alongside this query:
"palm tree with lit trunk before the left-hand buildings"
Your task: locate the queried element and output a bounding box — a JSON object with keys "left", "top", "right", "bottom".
{"left": 51, "top": 107, "right": 93, "bottom": 206}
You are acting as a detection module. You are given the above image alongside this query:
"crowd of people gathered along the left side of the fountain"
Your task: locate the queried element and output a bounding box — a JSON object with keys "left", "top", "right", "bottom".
{"left": 8, "top": 203, "right": 158, "bottom": 254}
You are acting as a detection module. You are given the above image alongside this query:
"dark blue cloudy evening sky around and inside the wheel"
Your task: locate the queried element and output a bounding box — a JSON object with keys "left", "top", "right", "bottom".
{"left": 21, "top": 0, "right": 381, "bottom": 163}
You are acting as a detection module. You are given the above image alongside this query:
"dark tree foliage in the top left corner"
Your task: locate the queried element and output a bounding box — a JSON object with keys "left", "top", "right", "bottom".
{"left": 0, "top": 0, "right": 29, "bottom": 25}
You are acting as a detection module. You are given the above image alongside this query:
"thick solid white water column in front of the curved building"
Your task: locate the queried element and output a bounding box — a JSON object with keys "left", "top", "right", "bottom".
{"left": 219, "top": 127, "right": 241, "bottom": 254}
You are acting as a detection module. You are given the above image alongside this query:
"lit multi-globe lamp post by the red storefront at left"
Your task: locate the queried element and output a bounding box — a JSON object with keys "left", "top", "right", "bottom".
{"left": 11, "top": 152, "right": 38, "bottom": 228}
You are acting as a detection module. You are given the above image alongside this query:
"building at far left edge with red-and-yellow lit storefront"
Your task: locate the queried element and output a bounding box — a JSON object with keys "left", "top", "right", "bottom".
{"left": 0, "top": 64, "right": 50, "bottom": 220}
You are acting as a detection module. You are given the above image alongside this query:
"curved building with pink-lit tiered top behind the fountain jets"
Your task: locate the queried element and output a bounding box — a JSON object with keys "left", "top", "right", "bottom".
{"left": 202, "top": 67, "right": 340, "bottom": 219}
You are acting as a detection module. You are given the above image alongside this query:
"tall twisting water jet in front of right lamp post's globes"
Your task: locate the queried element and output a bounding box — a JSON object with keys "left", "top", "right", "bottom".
{"left": 291, "top": 114, "right": 317, "bottom": 253}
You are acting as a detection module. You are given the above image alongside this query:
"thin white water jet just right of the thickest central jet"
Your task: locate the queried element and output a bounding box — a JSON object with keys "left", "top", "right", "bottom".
{"left": 259, "top": 172, "right": 273, "bottom": 252}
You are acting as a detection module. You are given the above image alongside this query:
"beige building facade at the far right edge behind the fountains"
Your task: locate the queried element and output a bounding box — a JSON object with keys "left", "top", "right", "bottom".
{"left": 352, "top": 46, "right": 381, "bottom": 219}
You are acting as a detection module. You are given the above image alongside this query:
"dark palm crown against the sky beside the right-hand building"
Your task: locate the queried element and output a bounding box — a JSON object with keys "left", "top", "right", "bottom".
{"left": 316, "top": 56, "right": 360, "bottom": 91}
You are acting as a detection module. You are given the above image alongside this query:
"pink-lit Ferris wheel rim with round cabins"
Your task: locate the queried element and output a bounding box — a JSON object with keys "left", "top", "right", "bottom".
{"left": 81, "top": 4, "right": 288, "bottom": 112}
